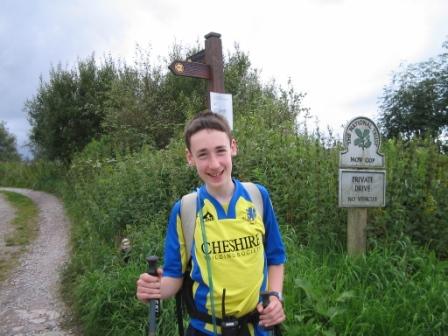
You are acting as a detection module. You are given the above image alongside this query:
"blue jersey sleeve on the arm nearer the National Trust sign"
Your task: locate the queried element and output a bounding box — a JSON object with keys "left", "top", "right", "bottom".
{"left": 257, "top": 184, "right": 286, "bottom": 265}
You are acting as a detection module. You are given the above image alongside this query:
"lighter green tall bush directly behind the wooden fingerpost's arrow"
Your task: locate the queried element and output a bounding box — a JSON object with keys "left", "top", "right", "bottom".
{"left": 103, "top": 46, "right": 205, "bottom": 150}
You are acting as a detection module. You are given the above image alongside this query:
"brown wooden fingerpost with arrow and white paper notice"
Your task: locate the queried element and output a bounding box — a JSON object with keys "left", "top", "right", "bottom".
{"left": 168, "top": 32, "right": 233, "bottom": 128}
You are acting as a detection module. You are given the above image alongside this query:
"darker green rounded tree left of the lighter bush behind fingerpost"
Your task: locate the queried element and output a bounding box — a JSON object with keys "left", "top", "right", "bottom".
{"left": 25, "top": 56, "right": 116, "bottom": 162}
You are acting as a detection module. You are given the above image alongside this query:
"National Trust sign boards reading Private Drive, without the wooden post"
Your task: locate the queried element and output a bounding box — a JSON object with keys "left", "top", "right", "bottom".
{"left": 339, "top": 117, "right": 386, "bottom": 208}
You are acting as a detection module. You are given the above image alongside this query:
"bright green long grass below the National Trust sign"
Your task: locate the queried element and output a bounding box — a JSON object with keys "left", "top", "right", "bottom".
{"left": 285, "top": 232, "right": 448, "bottom": 336}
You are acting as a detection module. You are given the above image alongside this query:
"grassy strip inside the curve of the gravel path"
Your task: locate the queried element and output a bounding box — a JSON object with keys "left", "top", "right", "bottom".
{"left": 0, "top": 191, "right": 38, "bottom": 281}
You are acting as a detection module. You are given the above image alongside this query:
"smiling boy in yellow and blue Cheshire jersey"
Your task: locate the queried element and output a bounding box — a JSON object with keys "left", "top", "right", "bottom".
{"left": 137, "top": 111, "right": 286, "bottom": 336}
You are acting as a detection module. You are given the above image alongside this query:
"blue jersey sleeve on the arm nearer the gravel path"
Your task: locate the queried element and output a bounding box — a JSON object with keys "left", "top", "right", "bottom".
{"left": 163, "top": 201, "right": 187, "bottom": 278}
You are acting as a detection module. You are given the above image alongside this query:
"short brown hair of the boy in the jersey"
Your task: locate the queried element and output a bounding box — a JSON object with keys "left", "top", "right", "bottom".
{"left": 184, "top": 110, "right": 233, "bottom": 150}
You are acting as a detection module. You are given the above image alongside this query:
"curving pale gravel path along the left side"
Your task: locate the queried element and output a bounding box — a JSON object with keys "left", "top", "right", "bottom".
{"left": 0, "top": 188, "right": 75, "bottom": 336}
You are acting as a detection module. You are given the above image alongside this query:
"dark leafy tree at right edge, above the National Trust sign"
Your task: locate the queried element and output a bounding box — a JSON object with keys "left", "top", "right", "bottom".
{"left": 380, "top": 40, "right": 448, "bottom": 140}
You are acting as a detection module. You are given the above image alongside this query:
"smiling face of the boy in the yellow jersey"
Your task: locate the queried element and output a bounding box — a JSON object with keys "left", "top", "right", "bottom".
{"left": 187, "top": 129, "right": 237, "bottom": 190}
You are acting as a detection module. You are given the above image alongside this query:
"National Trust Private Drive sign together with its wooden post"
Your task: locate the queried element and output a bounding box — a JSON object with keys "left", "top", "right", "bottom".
{"left": 339, "top": 117, "right": 386, "bottom": 255}
